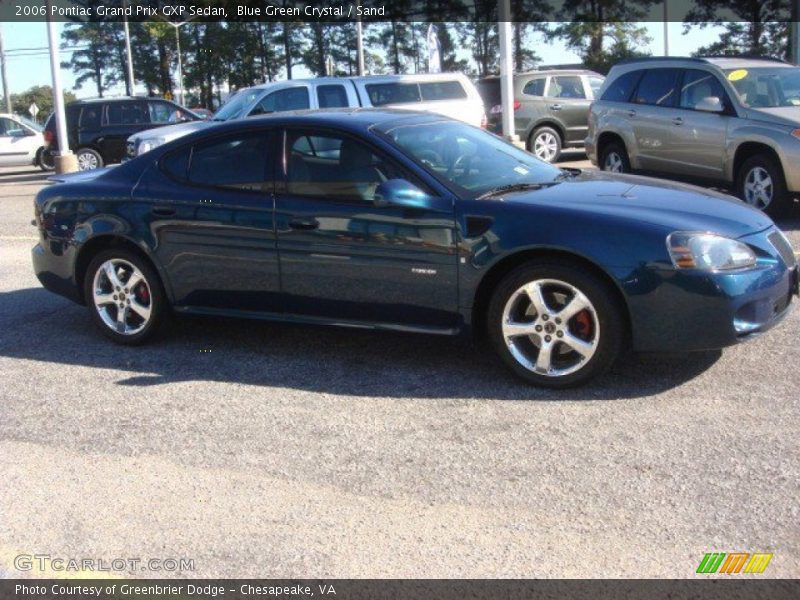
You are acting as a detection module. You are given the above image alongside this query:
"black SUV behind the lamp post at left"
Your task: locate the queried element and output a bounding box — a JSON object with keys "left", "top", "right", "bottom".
{"left": 44, "top": 97, "right": 200, "bottom": 171}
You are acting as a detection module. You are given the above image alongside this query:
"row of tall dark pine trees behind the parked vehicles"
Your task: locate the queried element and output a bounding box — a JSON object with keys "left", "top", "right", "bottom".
{"left": 62, "top": 0, "right": 789, "bottom": 107}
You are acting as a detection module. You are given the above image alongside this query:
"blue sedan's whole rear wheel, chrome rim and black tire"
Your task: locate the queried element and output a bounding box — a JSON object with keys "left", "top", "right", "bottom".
{"left": 84, "top": 249, "right": 166, "bottom": 345}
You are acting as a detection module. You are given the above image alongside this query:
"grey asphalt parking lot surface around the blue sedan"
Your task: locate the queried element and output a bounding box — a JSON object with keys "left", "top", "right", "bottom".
{"left": 0, "top": 156, "right": 800, "bottom": 578}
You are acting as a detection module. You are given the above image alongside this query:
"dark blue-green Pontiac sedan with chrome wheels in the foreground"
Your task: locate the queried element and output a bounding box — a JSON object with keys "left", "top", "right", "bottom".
{"left": 33, "top": 109, "right": 798, "bottom": 387}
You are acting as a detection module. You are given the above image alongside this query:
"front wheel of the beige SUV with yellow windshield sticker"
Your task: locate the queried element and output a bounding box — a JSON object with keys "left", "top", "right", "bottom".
{"left": 736, "top": 154, "right": 791, "bottom": 217}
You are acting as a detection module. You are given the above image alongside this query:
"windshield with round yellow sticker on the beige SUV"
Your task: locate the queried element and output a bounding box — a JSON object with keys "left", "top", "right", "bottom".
{"left": 725, "top": 67, "right": 800, "bottom": 108}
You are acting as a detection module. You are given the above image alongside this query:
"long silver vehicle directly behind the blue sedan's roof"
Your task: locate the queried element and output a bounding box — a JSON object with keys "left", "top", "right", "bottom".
{"left": 126, "top": 73, "right": 486, "bottom": 158}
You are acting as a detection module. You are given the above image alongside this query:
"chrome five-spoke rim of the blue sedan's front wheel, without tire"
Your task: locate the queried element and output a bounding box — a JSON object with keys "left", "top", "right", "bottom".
{"left": 502, "top": 279, "right": 600, "bottom": 377}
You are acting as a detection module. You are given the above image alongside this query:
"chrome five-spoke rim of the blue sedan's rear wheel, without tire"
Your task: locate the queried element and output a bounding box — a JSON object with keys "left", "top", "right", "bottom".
{"left": 92, "top": 258, "right": 153, "bottom": 335}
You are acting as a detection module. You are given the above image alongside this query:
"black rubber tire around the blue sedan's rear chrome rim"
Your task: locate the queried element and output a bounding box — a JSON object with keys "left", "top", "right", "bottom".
{"left": 83, "top": 248, "right": 167, "bottom": 346}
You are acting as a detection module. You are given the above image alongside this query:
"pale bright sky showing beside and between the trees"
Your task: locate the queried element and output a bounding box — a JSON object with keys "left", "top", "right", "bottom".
{"left": 0, "top": 23, "right": 719, "bottom": 98}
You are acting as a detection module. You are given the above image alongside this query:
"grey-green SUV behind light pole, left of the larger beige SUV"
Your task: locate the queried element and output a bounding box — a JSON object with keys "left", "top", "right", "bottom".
{"left": 475, "top": 69, "right": 604, "bottom": 162}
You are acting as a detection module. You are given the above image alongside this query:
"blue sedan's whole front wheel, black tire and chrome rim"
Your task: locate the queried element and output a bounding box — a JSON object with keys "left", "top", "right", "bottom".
{"left": 488, "top": 259, "right": 625, "bottom": 388}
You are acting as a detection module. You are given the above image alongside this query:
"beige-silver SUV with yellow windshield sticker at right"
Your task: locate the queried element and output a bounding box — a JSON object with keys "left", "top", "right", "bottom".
{"left": 586, "top": 57, "right": 800, "bottom": 216}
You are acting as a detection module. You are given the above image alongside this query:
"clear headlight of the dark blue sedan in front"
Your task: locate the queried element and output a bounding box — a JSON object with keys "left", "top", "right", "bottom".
{"left": 667, "top": 231, "right": 756, "bottom": 271}
